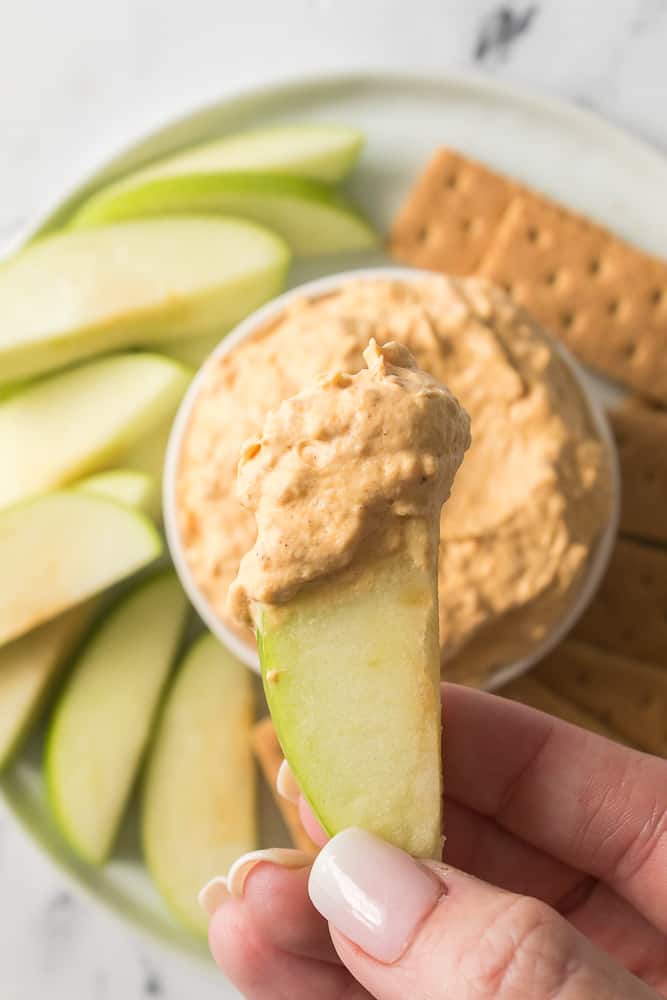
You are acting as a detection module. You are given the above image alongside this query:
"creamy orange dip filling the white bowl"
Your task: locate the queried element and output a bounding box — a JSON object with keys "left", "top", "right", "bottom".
{"left": 176, "top": 276, "right": 610, "bottom": 681}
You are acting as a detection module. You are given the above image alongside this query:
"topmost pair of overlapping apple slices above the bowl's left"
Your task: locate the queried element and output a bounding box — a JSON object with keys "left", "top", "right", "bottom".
{"left": 70, "top": 126, "right": 377, "bottom": 257}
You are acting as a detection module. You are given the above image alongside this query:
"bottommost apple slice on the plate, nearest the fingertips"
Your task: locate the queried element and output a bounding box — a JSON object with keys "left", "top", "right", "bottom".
{"left": 142, "top": 635, "right": 257, "bottom": 935}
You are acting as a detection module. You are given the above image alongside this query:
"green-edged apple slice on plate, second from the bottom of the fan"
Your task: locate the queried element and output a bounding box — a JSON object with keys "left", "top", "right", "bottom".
{"left": 45, "top": 571, "right": 188, "bottom": 864}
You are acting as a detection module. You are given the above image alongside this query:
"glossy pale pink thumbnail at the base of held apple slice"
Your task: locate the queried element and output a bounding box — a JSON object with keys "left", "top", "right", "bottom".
{"left": 308, "top": 828, "right": 443, "bottom": 963}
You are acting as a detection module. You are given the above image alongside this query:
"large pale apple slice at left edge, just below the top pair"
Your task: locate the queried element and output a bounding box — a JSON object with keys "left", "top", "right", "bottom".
{"left": 0, "top": 217, "right": 289, "bottom": 384}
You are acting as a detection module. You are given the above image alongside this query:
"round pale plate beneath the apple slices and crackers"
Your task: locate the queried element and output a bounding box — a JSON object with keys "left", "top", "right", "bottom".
{"left": 2, "top": 74, "right": 667, "bottom": 954}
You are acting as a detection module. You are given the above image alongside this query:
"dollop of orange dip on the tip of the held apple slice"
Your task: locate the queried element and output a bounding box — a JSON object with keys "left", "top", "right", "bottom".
{"left": 228, "top": 340, "right": 470, "bottom": 625}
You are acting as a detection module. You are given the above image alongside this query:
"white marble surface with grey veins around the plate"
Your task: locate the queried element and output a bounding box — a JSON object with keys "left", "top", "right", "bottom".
{"left": 0, "top": 0, "right": 667, "bottom": 1000}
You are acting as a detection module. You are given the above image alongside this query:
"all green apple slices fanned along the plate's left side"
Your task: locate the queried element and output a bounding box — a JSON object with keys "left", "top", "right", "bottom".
{"left": 0, "top": 126, "right": 376, "bottom": 932}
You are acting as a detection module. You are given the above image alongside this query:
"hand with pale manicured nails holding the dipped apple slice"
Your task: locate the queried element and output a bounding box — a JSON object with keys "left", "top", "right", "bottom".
{"left": 210, "top": 685, "right": 667, "bottom": 1000}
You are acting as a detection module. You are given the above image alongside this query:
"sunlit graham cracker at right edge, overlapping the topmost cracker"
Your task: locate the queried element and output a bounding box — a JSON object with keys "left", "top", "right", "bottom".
{"left": 478, "top": 192, "right": 667, "bottom": 403}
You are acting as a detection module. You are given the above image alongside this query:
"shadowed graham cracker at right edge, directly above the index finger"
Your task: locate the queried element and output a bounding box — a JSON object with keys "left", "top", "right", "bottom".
{"left": 535, "top": 640, "right": 667, "bottom": 757}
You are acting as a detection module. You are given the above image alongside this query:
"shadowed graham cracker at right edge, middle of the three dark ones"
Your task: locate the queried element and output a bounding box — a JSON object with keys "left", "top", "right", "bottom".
{"left": 573, "top": 539, "right": 667, "bottom": 675}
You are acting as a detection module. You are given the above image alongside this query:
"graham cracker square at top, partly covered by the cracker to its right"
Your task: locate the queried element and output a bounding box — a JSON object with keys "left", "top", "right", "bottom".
{"left": 389, "top": 149, "right": 519, "bottom": 275}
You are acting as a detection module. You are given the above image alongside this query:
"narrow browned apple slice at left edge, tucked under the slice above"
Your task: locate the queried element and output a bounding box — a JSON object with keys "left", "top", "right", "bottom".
{"left": 0, "top": 601, "right": 96, "bottom": 769}
